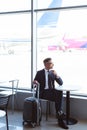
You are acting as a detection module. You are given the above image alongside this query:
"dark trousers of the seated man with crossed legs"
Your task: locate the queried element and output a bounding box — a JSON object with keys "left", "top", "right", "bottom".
{"left": 40, "top": 89, "right": 63, "bottom": 113}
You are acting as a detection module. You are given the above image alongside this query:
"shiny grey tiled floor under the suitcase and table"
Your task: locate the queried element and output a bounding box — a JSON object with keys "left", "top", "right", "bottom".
{"left": 0, "top": 112, "right": 87, "bottom": 130}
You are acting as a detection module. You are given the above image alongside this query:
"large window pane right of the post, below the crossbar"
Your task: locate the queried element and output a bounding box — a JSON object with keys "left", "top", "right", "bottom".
{"left": 37, "top": 2, "right": 87, "bottom": 94}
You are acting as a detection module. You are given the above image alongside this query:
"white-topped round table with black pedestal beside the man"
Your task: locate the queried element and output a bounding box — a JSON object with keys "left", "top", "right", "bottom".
{"left": 55, "top": 86, "right": 78, "bottom": 125}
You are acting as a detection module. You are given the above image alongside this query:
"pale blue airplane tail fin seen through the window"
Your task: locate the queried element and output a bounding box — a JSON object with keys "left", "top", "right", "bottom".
{"left": 37, "top": 0, "right": 62, "bottom": 28}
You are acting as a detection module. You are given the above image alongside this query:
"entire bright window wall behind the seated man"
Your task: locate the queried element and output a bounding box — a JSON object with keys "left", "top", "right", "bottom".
{"left": 0, "top": 0, "right": 87, "bottom": 94}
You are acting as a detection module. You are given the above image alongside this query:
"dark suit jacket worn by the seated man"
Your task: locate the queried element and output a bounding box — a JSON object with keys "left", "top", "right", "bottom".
{"left": 34, "top": 69, "right": 63, "bottom": 92}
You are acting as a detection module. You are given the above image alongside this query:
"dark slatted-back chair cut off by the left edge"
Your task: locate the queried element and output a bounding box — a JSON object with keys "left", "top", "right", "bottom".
{"left": 0, "top": 95, "right": 10, "bottom": 130}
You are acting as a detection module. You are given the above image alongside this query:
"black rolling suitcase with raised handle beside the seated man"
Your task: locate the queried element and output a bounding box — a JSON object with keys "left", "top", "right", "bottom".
{"left": 23, "top": 84, "right": 41, "bottom": 127}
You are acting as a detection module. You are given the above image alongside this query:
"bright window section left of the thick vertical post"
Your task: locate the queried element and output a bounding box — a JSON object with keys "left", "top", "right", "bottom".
{"left": 0, "top": 0, "right": 31, "bottom": 89}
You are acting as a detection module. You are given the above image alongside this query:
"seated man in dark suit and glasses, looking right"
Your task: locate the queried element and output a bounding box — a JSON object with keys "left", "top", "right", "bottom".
{"left": 34, "top": 58, "right": 68, "bottom": 129}
